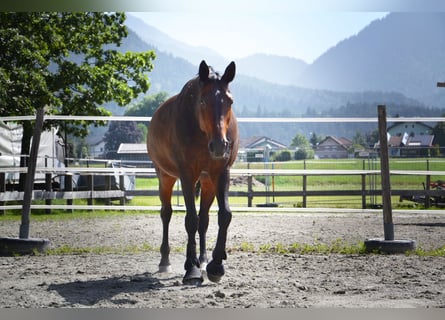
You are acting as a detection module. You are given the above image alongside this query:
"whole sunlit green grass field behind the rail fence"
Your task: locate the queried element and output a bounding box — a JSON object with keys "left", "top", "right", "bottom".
{"left": 0, "top": 158, "right": 445, "bottom": 215}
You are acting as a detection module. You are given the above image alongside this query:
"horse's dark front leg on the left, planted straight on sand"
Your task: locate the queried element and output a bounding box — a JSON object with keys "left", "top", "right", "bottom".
{"left": 181, "top": 179, "right": 204, "bottom": 285}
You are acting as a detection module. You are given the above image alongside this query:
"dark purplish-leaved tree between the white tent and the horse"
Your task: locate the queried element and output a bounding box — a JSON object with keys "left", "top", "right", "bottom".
{"left": 104, "top": 121, "right": 143, "bottom": 158}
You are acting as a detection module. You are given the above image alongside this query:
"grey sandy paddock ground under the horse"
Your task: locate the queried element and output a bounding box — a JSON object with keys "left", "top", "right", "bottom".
{"left": 0, "top": 211, "right": 445, "bottom": 308}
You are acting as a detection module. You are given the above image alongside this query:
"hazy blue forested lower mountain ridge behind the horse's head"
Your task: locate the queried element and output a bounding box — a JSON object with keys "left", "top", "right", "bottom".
{"left": 113, "top": 28, "right": 430, "bottom": 144}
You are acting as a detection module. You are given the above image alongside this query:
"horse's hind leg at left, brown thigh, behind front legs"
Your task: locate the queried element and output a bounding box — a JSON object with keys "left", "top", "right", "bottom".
{"left": 158, "top": 173, "right": 176, "bottom": 272}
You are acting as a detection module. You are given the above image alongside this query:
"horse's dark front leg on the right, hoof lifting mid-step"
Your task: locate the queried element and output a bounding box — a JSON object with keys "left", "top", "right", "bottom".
{"left": 207, "top": 168, "right": 232, "bottom": 282}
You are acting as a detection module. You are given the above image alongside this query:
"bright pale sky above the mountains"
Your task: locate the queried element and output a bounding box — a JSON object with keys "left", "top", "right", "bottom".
{"left": 129, "top": 10, "right": 387, "bottom": 63}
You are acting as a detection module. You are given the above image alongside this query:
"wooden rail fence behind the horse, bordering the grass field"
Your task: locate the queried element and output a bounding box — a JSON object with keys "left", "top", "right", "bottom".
{"left": 0, "top": 167, "right": 445, "bottom": 214}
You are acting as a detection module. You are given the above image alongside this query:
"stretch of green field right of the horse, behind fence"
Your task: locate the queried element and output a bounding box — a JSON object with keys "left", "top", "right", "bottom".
{"left": 232, "top": 158, "right": 445, "bottom": 208}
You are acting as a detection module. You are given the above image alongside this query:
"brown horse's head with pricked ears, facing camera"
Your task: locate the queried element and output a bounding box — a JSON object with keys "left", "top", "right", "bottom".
{"left": 197, "top": 60, "right": 235, "bottom": 159}
